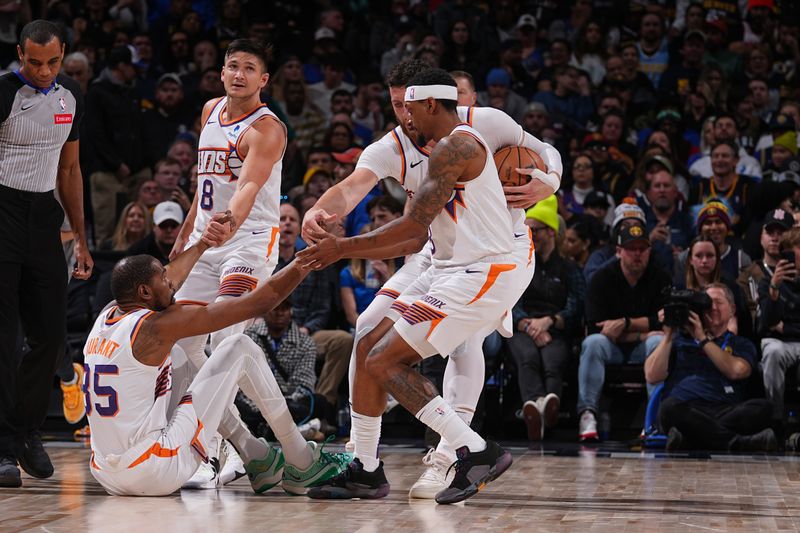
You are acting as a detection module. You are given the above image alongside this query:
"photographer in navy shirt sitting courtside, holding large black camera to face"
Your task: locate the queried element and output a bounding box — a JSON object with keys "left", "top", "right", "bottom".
{"left": 644, "top": 283, "right": 777, "bottom": 452}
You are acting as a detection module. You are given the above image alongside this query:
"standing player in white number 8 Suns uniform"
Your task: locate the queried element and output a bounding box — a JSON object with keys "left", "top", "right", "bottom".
{"left": 171, "top": 39, "right": 286, "bottom": 488}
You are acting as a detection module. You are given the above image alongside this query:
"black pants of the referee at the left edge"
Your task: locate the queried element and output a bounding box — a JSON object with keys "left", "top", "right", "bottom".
{"left": 0, "top": 185, "right": 67, "bottom": 455}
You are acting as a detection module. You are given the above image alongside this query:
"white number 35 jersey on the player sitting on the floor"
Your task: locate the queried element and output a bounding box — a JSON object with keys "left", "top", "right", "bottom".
{"left": 83, "top": 307, "right": 172, "bottom": 468}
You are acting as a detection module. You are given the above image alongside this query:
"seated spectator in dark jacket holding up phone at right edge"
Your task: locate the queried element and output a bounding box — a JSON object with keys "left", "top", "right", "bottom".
{"left": 758, "top": 228, "right": 800, "bottom": 420}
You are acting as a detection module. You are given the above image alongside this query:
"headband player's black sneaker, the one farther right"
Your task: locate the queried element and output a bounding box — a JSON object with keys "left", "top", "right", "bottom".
{"left": 436, "top": 441, "right": 512, "bottom": 503}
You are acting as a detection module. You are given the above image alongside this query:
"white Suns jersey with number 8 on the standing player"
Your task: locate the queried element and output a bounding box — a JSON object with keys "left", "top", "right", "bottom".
{"left": 190, "top": 97, "right": 283, "bottom": 244}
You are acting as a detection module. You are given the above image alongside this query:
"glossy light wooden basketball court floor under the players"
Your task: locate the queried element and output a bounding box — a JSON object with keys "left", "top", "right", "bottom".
{"left": 0, "top": 444, "right": 800, "bottom": 533}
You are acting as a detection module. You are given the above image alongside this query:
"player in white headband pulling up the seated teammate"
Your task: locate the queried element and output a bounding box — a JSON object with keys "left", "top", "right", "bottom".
{"left": 298, "top": 69, "right": 533, "bottom": 503}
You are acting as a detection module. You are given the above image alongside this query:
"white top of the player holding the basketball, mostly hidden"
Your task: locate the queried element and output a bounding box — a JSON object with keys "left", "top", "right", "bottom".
{"left": 356, "top": 106, "right": 528, "bottom": 236}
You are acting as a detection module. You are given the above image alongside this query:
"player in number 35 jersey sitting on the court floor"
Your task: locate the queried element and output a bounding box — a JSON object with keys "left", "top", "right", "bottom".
{"left": 83, "top": 215, "right": 346, "bottom": 496}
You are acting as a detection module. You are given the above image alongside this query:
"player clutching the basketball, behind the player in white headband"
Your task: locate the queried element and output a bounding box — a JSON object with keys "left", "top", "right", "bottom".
{"left": 303, "top": 60, "right": 562, "bottom": 498}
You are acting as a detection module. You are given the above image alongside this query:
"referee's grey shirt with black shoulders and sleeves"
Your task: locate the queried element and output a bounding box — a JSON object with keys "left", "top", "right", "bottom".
{"left": 0, "top": 71, "right": 83, "bottom": 192}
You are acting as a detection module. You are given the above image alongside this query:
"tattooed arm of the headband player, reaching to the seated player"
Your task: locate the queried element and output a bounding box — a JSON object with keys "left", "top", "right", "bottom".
{"left": 297, "top": 135, "right": 484, "bottom": 268}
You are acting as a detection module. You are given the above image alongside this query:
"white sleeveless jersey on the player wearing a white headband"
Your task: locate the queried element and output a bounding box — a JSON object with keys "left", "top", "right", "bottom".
{"left": 429, "top": 124, "right": 514, "bottom": 268}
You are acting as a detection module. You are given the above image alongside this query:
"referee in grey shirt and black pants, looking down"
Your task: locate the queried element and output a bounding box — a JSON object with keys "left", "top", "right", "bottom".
{"left": 0, "top": 20, "right": 92, "bottom": 487}
